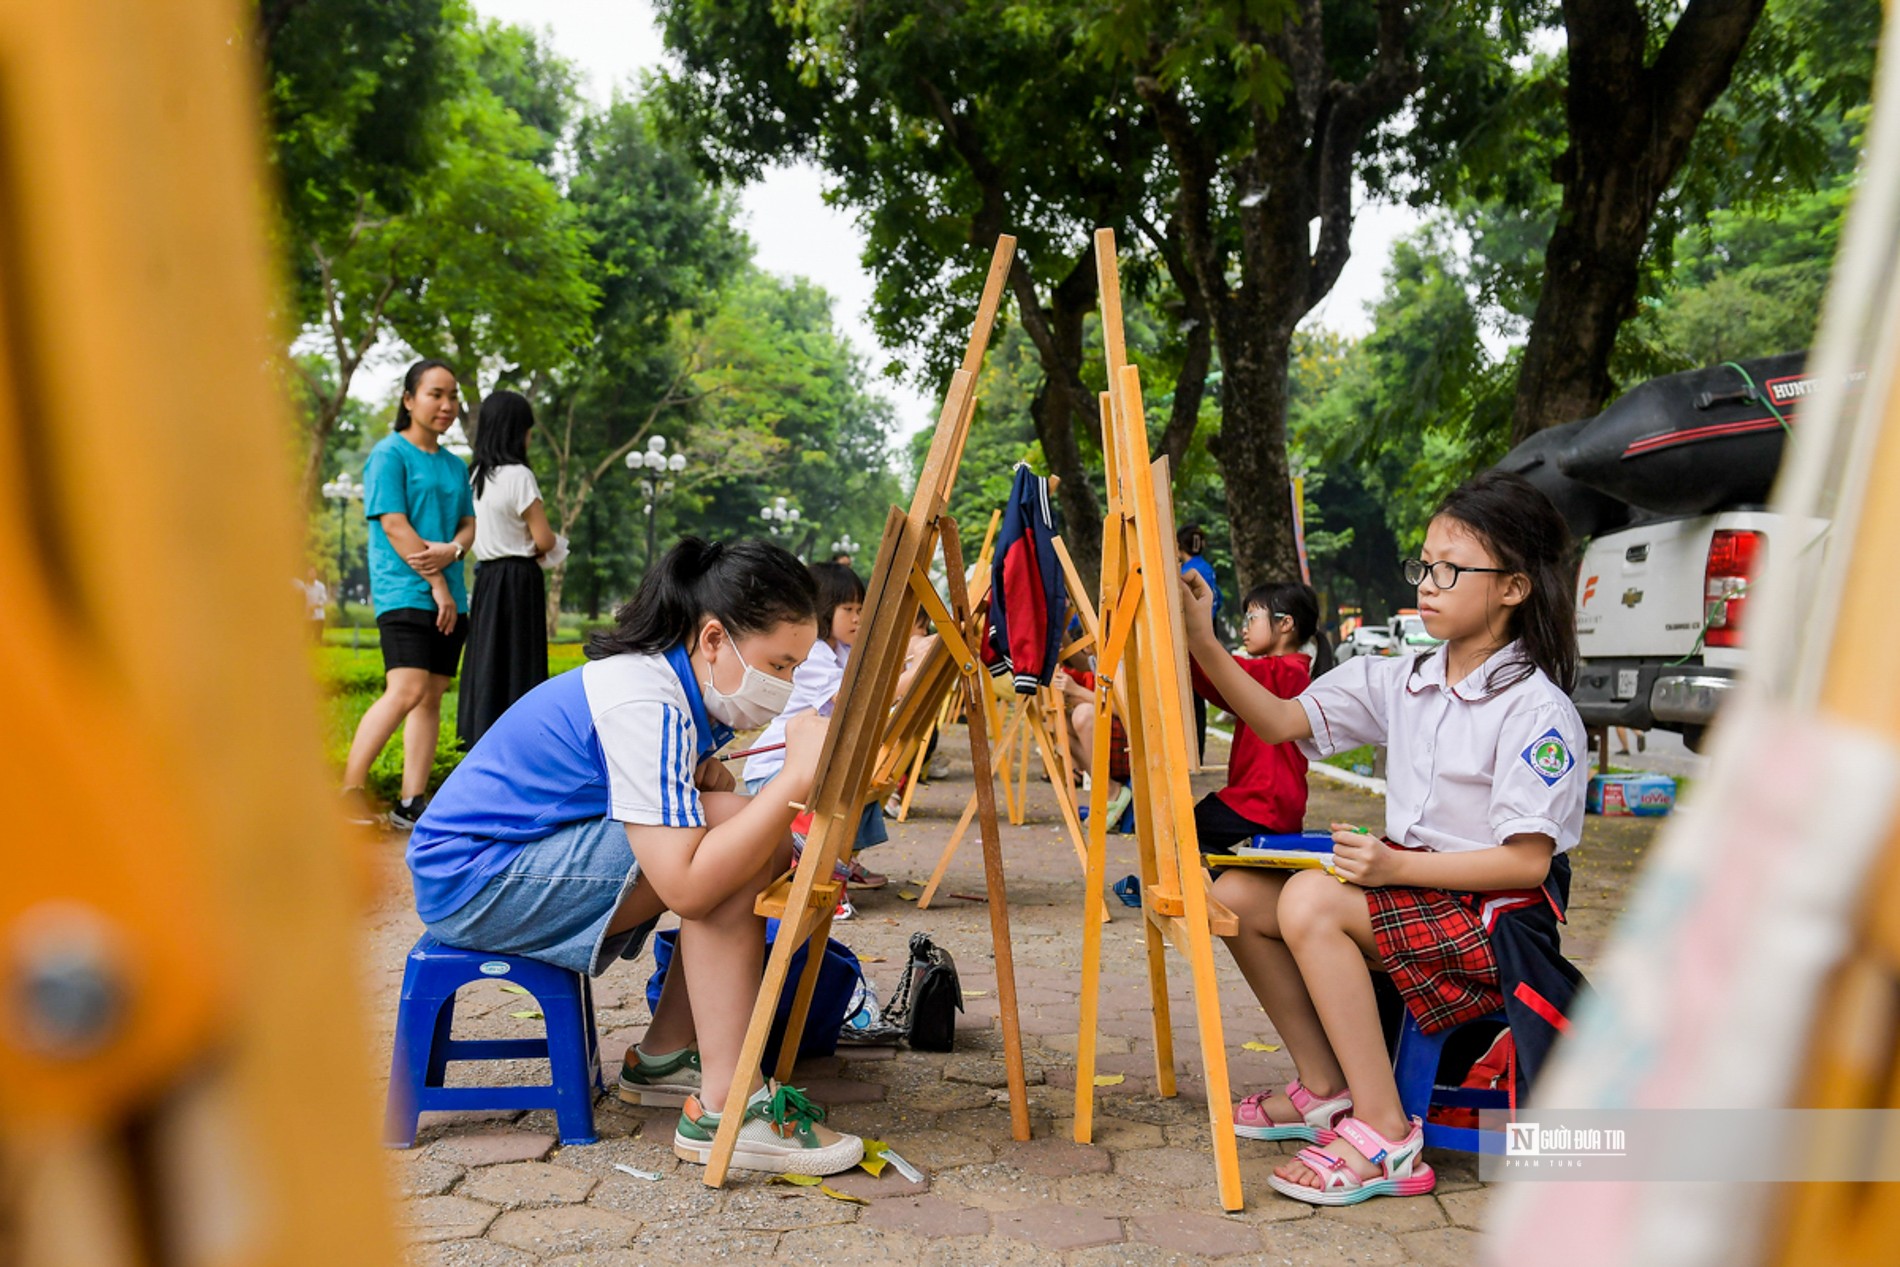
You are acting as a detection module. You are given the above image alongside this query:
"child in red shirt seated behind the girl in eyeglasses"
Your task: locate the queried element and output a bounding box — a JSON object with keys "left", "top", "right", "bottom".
{"left": 1193, "top": 581, "right": 1332, "bottom": 853}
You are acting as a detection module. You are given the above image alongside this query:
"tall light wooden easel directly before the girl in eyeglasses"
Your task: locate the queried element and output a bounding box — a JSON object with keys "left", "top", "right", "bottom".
{"left": 1075, "top": 228, "right": 1241, "bottom": 1210}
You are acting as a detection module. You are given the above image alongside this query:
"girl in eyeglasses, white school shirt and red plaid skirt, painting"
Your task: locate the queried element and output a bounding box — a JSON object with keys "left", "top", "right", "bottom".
{"left": 1184, "top": 471, "right": 1588, "bottom": 1204}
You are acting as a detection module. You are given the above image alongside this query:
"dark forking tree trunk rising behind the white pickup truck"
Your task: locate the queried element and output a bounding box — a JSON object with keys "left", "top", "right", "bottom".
{"left": 1511, "top": 0, "right": 1763, "bottom": 444}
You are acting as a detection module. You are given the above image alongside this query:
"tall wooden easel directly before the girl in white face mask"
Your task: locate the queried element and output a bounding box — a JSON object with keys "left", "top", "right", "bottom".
{"left": 705, "top": 234, "right": 1030, "bottom": 1187}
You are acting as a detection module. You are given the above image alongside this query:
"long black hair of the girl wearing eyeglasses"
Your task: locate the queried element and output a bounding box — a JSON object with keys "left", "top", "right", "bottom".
{"left": 1433, "top": 471, "right": 1577, "bottom": 693}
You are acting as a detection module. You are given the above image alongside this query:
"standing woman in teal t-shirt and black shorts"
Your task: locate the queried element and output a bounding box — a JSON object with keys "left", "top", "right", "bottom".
{"left": 344, "top": 361, "right": 475, "bottom": 828}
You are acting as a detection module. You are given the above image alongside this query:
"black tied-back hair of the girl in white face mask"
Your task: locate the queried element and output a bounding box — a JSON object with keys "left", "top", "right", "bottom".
{"left": 587, "top": 538, "right": 819, "bottom": 659}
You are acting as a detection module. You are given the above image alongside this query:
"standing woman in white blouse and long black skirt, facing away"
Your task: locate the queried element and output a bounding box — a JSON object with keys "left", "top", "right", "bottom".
{"left": 456, "top": 391, "right": 564, "bottom": 747}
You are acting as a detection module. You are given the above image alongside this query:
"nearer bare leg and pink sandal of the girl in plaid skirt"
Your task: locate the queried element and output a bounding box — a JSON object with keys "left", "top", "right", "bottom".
{"left": 1275, "top": 872, "right": 1412, "bottom": 1187}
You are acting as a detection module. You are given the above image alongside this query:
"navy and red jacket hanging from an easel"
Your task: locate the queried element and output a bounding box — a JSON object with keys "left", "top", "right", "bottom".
{"left": 982, "top": 462, "right": 1068, "bottom": 695}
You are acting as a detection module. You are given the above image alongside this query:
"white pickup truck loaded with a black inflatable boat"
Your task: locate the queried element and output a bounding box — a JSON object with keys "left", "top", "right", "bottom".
{"left": 1499, "top": 353, "right": 1828, "bottom": 748}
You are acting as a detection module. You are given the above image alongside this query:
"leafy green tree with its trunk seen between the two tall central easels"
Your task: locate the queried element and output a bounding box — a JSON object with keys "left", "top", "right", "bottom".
{"left": 657, "top": 0, "right": 1210, "bottom": 574}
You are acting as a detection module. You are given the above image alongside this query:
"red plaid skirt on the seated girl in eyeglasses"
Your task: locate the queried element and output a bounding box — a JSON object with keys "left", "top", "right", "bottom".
{"left": 1366, "top": 887, "right": 1505, "bottom": 1033}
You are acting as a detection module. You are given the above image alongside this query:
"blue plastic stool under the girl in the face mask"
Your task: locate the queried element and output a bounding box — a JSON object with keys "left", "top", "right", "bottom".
{"left": 382, "top": 933, "right": 602, "bottom": 1147}
